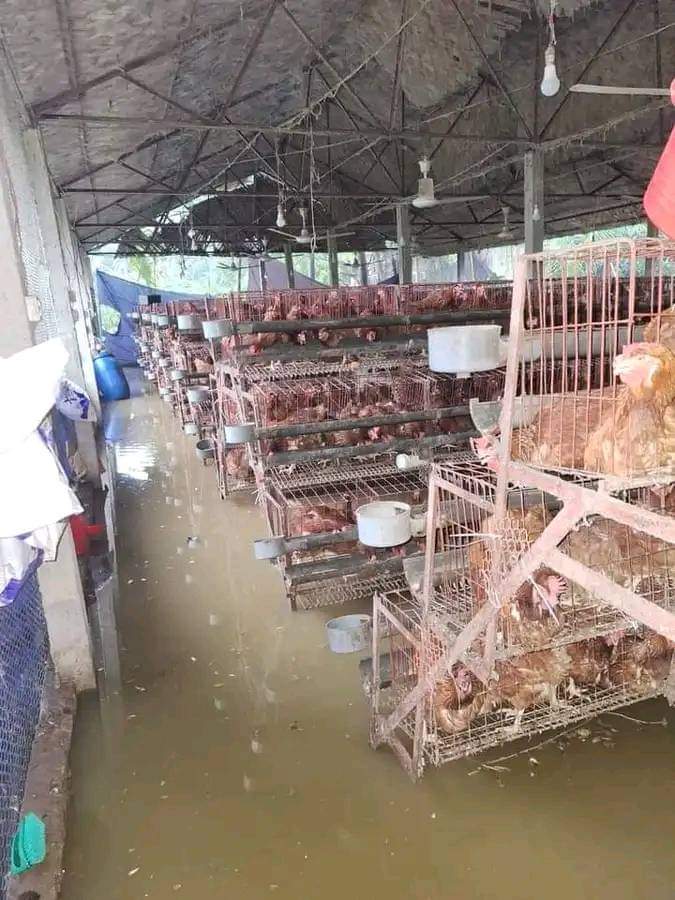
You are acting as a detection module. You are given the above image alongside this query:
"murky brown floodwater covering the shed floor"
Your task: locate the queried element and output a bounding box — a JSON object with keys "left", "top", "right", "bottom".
{"left": 63, "top": 386, "right": 675, "bottom": 900}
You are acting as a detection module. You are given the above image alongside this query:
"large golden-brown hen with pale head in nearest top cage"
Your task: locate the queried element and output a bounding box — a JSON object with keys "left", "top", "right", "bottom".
{"left": 584, "top": 343, "right": 675, "bottom": 477}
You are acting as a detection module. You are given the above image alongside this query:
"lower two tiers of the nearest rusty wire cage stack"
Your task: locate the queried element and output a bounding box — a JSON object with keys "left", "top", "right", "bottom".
{"left": 373, "top": 453, "right": 675, "bottom": 777}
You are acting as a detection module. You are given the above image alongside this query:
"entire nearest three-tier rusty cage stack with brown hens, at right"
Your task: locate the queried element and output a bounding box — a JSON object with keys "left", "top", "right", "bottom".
{"left": 372, "top": 241, "right": 675, "bottom": 777}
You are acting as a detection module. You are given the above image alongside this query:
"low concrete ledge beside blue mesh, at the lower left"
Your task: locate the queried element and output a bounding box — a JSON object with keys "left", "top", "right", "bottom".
{"left": 7, "top": 685, "right": 76, "bottom": 900}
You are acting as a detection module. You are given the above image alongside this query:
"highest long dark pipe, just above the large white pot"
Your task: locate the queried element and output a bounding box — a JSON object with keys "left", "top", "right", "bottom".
{"left": 232, "top": 309, "right": 511, "bottom": 334}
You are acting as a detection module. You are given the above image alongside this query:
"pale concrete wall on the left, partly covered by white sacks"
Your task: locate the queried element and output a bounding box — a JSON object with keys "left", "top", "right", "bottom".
{"left": 0, "top": 57, "right": 98, "bottom": 690}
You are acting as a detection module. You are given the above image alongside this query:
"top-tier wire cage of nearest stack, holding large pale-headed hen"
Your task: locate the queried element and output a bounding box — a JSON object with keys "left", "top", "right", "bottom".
{"left": 502, "top": 239, "right": 675, "bottom": 485}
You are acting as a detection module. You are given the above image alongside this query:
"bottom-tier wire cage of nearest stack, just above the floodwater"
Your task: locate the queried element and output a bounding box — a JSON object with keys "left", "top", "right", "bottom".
{"left": 370, "top": 582, "right": 672, "bottom": 778}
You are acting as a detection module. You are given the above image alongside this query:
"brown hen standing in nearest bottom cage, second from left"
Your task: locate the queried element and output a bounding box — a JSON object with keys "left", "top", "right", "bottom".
{"left": 488, "top": 647, "right": 569, "bottom": 733}
